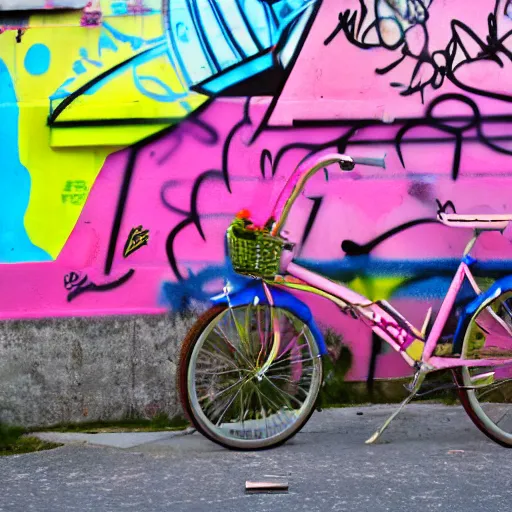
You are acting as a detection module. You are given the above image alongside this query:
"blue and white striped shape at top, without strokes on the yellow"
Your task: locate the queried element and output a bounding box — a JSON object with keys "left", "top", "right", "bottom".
{"left": 167, "top": 0, "right": 316, "bottom": 94}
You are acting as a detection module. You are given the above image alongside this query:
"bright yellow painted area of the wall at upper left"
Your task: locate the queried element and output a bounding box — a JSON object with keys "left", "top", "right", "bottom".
{"left": 0, "top": 8, "right": 206, "bottom": 259}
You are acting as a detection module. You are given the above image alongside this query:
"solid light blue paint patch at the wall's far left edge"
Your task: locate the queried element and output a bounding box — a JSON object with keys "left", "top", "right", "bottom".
{"left": 0, "top": 59, "right": 52, "bottom": 263}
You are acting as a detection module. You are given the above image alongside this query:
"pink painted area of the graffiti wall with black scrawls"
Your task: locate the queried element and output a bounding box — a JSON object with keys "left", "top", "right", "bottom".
{"left": 0, "top": 1, "right": 512, "bottom": 380}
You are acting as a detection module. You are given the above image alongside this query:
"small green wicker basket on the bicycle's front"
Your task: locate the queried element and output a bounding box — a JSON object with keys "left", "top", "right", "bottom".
{"left": 227, "top": 219, "right": 284, "bottom": 279}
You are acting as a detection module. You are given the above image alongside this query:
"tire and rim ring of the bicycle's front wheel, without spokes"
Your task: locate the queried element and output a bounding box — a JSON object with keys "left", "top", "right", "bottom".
{"left": 177, "top": 305, "right": 322, "bottom": 451}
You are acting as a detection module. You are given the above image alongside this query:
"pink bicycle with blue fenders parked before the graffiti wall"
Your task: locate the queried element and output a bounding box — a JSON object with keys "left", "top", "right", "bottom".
{"left": 178, "top": 154, "right": 512, "bottom": 450}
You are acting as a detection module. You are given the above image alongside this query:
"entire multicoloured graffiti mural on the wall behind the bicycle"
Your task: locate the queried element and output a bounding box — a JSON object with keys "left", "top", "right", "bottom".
{"left": 0, "top": 0, "right": 512, "bottom": 380}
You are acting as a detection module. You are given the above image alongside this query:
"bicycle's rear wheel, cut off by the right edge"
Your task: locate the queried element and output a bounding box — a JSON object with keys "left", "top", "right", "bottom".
{"left": 454, "top": 291, "right": 512, "bottom": 448}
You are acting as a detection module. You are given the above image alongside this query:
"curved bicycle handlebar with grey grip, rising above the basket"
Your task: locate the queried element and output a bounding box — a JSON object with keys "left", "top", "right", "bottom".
{"left": 272, "top": 153, "right": 386, "bottom": 235}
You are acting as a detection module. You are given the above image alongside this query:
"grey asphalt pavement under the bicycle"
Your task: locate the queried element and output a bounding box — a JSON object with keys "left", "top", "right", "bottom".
{"left": 0, "top": 404, "right": 512, "bottom": 512}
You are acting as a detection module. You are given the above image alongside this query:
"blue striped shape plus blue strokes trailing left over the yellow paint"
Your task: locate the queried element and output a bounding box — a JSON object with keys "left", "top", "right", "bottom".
{"left": 50, "top": 0, "right": 316, "bottom": 112}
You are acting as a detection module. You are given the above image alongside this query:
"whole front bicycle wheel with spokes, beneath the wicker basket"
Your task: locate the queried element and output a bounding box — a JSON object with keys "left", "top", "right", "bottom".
{"left": 178, "top": 305, "right": 322, "bottom": 450}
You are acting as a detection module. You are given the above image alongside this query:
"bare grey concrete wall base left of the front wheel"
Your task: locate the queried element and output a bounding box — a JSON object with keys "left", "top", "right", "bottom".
{"left": 0, "top": 314, "right": 197, "bottom": 427}
